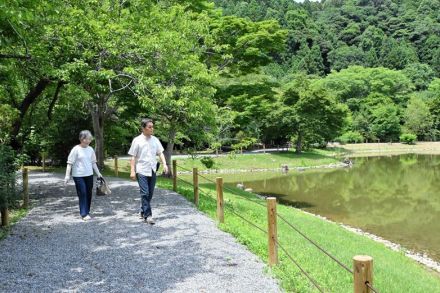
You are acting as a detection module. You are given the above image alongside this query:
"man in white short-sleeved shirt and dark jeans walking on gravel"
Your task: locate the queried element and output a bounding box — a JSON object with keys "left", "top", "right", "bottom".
{"left": 128, "top": 118, "right": 168, "bottom": 225}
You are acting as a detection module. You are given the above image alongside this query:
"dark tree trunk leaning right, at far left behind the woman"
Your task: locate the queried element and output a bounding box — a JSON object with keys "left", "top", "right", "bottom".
{"left": 11, "top": 78, "right": 50, "bottom": 150}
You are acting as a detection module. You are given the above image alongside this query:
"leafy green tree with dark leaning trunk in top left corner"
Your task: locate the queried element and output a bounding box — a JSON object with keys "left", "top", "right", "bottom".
{"left": 0, "top": 1, "right": 57, "bottom": 150}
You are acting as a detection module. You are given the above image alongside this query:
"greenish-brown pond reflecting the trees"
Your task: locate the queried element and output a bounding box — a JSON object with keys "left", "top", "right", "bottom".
{"left": 199, "top": 155, "right": 440, "bottom": 261}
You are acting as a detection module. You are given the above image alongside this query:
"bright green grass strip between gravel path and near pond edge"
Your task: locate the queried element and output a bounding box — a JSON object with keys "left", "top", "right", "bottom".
{"left": 158, "top": 180, "right": 440, "bottom": 292}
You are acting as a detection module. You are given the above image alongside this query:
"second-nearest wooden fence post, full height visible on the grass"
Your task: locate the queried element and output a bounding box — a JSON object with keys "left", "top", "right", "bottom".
{"left": 266, "top": 197, "right": 278, "bottom": 266}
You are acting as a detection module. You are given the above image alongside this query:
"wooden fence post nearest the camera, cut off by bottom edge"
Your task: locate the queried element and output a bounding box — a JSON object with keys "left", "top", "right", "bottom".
{"left": 353, "top": 255, "right": 373, "bottom": 293}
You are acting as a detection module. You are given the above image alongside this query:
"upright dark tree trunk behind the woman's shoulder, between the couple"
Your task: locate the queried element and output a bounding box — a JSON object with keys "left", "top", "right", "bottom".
{"left": 90, "top": 96, "right": 105, "bottom": 170}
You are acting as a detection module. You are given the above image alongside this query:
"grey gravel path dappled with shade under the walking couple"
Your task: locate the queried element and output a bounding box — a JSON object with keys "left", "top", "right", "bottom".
{"left": 0, "top": 173, "right": 281, "bottom": 292}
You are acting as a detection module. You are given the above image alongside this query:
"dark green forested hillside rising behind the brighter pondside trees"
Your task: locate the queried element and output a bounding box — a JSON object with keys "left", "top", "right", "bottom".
{"left": 215, "top": 0, "right": 440, "bottom": 76}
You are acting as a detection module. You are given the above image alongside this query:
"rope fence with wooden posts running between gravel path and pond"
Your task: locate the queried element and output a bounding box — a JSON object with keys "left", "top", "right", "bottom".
{"left": 173, "top": 160, "right": 379, "bottom": 293}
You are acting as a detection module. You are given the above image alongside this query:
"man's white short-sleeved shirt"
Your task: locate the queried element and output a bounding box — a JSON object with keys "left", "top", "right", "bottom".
{"left": 128, "top": 134, "right": 164, "bottom": 176}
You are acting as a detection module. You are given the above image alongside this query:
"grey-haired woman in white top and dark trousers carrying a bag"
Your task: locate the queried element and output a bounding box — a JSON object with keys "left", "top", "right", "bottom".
{"left": 64, "top": 130, "right": 102, "bottom": 221}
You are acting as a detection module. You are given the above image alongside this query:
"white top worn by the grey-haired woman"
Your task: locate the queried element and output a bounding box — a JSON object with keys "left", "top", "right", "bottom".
{"left": 67, "top": 145, "right": 96, "bottom": 177}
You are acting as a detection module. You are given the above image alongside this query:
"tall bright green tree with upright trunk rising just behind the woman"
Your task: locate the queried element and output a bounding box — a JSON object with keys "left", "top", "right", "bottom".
{"left": 36, "top": 1, "right": 148, "bottom": 168}
